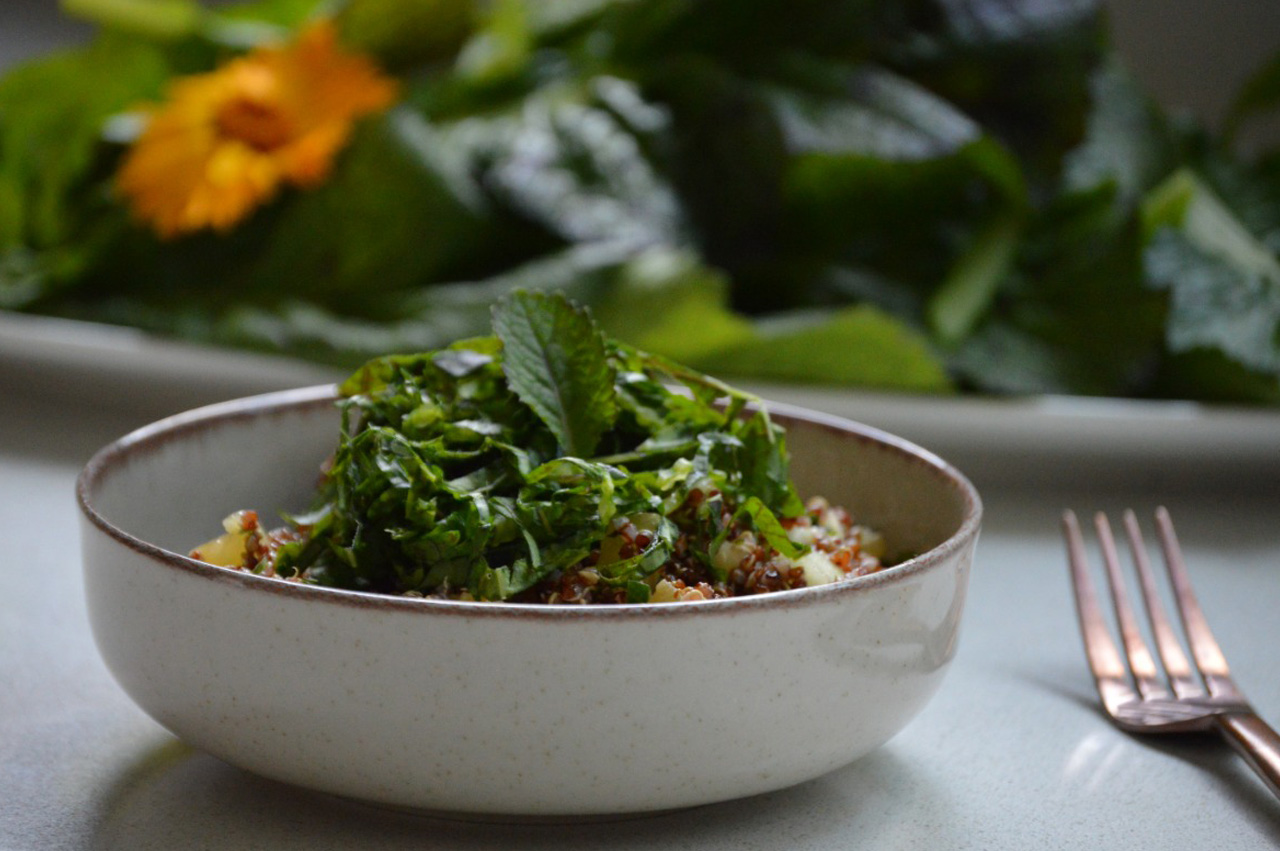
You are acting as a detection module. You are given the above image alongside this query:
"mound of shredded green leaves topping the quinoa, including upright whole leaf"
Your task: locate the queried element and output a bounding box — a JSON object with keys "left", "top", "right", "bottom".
{"left": 282, "top": 292, "right": 804, "bottom": 603}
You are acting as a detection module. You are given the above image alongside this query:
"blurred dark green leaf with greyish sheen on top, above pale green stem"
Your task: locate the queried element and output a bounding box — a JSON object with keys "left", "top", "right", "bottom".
{"left": 769, "top": 64, "right": 1025, "bottom": 308}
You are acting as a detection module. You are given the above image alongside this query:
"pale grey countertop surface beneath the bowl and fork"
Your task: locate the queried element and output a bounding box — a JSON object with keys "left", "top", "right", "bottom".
{"left": 0, "top": 388, "right": 1280, "bottom": 851}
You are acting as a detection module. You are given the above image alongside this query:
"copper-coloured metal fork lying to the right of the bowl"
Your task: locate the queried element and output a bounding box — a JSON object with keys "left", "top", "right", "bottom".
{"left": 1062, "top": 508, "right": 1280, "bottom": 796}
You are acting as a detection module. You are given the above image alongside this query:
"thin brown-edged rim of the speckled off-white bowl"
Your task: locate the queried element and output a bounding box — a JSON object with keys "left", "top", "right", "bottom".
{"left": 76, "top": 384, "right": 983, "bottom": 622}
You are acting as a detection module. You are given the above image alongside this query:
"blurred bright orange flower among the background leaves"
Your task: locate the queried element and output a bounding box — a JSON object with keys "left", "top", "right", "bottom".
{"left": 118, "top": 22, "right": 397, "bottom": 237}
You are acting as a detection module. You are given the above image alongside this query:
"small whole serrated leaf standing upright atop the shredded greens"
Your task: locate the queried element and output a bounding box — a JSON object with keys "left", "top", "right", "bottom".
{"left": 493, "top": 292, "right": 618, "bottom": 458}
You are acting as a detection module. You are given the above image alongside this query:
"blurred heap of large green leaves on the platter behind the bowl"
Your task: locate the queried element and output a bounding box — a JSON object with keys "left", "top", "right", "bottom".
{"left": 0, "top": 0, "right": 1280, "bottom": 402}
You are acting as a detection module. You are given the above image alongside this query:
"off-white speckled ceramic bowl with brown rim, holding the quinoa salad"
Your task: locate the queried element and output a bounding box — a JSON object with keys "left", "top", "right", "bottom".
{"left": 77, "top": 386, "right": 982, "bottom": 816}
